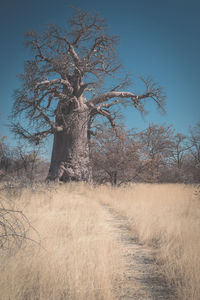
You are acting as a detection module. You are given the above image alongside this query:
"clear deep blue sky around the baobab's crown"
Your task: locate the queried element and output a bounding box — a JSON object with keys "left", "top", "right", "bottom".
{"left": 0, "top": 0, "right": 200, "bottom": 149}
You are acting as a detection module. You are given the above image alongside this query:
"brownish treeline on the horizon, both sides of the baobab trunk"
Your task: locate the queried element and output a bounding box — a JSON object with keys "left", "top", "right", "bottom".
{"left": 0, "top": 122, "right": 200, "bottom": 185}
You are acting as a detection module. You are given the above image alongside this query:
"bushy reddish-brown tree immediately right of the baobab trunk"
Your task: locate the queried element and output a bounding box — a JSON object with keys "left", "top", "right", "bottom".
{"left": 90, "top": 124, "right": 140, "bottom": 185}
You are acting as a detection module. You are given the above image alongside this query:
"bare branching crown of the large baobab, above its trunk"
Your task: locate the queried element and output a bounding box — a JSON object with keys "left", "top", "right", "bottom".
{"left": 12, "top": 9, "right": 165, "bottom": 143}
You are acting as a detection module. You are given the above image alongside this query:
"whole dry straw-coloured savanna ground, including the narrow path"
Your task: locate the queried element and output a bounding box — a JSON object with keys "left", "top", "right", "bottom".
{"left": 0, "top": 184, "right": 200, "bottom": 300}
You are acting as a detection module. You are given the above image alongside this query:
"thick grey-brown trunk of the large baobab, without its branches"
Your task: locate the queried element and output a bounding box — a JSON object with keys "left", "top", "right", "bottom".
{"left": 47, "top": 98, "right": 92, "bottom": 182}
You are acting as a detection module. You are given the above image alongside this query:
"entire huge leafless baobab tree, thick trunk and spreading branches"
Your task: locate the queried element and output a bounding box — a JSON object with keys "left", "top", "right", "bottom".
{"left": 12, "top": 9, "right": 164, "bottom": 182}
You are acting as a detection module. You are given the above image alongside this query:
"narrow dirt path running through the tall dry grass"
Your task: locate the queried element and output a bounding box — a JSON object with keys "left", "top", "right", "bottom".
{"left": 104, "top": 205, "right": 177, "bottom": 300}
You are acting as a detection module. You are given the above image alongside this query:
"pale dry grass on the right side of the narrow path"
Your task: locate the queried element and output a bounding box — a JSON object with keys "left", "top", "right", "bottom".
{"left": 95, "top": 184, "right": 200, "bottom": 300}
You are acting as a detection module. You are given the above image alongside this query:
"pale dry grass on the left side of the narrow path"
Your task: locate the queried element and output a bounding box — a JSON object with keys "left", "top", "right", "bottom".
{"left": 0, "top": 184, "right": 124, "bottom": 300}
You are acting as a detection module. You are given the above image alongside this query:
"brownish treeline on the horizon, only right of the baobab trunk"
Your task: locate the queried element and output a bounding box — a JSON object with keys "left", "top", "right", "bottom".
{"left": 91, "top": 122, "right": 200, "bottom": 185}
